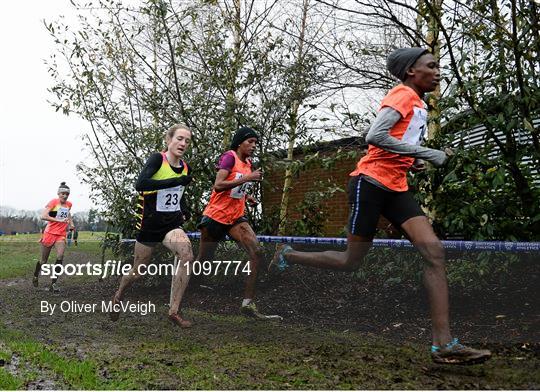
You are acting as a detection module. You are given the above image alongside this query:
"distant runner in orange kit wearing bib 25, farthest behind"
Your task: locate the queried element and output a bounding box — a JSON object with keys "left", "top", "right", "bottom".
{"left": 32, "top": 182, "right": 75, "bottom": 293}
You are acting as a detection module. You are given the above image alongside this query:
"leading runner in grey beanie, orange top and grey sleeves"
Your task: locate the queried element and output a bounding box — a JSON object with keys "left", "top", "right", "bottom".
{"left": 270, "top": 48, "right": 491, "bottom": 364}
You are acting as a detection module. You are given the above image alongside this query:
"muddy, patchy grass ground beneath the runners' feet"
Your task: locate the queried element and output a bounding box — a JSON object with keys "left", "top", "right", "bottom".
{"left": 0, "top": 253, "right": 540, "bottom": 389}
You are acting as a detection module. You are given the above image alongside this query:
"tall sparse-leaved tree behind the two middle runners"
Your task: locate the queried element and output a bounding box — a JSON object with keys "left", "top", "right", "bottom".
{"left": 46, "top": 0, "right": 338, "bottom": 236}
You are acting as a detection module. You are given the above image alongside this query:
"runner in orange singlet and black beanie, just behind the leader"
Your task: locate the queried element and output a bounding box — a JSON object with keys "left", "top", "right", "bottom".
{"left": 198, "top": 127, "right": 281, "bottom": 319}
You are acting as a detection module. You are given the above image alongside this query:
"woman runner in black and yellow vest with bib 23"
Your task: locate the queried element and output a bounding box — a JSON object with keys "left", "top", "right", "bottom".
{"left": 109, "top": 124, "right": 193, "bottom": 328}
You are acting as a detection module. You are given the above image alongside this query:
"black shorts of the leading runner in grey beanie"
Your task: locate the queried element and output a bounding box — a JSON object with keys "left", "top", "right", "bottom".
{"left": 349, "top": 176, "right": 424, "bottom": 238}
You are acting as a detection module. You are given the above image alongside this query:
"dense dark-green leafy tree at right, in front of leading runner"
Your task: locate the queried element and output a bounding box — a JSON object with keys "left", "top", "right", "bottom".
{"left": 412, "top": 0, "right": 540, "bottom": 240}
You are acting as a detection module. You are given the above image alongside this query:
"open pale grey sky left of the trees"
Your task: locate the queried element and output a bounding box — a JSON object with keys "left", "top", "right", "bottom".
{"left": 0, "top": 0, "right": 92, "bottom": 212}
